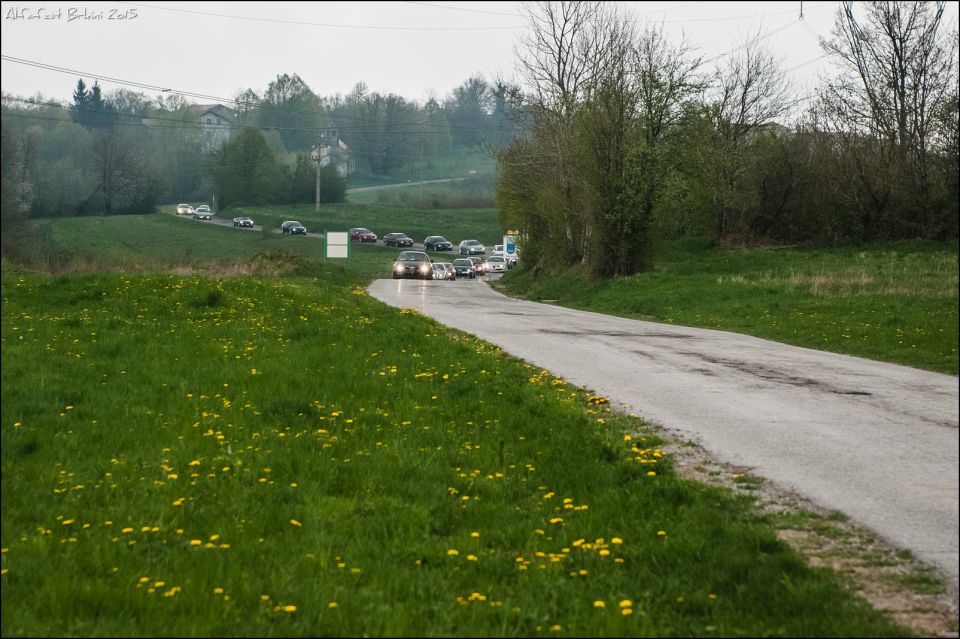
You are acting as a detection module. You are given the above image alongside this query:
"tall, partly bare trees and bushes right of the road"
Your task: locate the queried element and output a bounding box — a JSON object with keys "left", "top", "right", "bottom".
{"left": 497, "top": 1, "right": 960, "bottom": 276}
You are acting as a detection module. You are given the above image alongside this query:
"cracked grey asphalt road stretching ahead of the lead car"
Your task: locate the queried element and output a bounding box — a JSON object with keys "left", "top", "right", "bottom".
{"left": 369, "top": 280, "right": 960, "bottom": 587}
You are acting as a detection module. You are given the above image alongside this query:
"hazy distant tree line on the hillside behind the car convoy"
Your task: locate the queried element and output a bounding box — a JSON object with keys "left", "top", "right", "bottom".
{"left": 2, "top": 69, "right": 514, "bottom": 238}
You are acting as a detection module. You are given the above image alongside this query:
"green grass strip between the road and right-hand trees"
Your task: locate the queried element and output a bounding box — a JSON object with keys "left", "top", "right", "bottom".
{"left": 498, "top": 240, "right": 958, "bottom": 375}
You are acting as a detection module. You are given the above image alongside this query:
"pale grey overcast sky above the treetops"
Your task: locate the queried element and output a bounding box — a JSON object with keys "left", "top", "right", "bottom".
{"left": 0, "top": 1, "right": 957, "bottom": 109}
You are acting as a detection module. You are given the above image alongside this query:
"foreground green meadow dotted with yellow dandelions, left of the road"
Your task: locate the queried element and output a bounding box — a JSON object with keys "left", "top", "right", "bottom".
{"left": 0, "top": 268, "right": 908, "bottom": 637}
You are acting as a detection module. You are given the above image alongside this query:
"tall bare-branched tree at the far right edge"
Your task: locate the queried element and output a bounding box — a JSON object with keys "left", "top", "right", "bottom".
{"left": 817, "top": 2, "right": 957, "bottom": 239}
